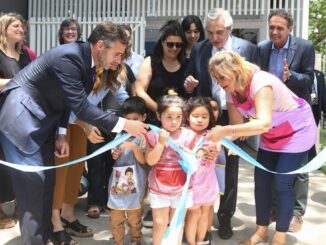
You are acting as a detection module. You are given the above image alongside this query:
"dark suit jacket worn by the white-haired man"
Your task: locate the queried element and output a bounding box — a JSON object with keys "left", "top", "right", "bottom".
{"left": 185, "top": 36, "right": 258, "bottom": 96}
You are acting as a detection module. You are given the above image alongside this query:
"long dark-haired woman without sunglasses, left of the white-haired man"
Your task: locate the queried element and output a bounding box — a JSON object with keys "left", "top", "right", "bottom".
{"left": 181, "top": 15, "right": 205, "bottom": 59}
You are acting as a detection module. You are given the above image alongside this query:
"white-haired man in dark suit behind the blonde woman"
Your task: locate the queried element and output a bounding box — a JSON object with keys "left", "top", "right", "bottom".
{"left": 184, "top": 9, "right": 258, "bottom": 240}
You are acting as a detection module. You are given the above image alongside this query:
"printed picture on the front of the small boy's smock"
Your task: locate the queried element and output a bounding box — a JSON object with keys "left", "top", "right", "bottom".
{"left": 110, "top": 165, "right": 137, "bottom": 195}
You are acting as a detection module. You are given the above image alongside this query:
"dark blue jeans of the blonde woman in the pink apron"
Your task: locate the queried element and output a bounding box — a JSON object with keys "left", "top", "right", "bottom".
{"left": 255, "top": 149, "right": 308, "bottom": 232}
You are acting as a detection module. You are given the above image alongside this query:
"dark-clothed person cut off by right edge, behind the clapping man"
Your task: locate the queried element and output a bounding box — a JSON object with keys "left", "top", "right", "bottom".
{"left": 308, "top": 69, "right": 326, "bottom": 161}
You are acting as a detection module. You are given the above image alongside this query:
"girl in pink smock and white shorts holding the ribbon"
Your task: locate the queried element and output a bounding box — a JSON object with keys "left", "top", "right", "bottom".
{"left": 145, "top": 95, "right": 195, "bottom": 245}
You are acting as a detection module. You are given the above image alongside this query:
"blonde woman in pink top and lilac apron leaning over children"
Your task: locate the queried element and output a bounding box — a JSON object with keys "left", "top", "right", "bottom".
{"left": 207, "top": 51, "right": 317, "bottom": 245}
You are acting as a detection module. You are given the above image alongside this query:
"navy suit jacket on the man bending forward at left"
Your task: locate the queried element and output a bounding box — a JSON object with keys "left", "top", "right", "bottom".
{"left": 0, "top": 42, "right": 118, "bottom": 154}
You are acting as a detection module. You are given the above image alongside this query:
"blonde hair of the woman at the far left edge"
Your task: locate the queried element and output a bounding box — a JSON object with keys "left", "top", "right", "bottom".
{"left": 0, "top": 13, "right": 25, "bottom": 53}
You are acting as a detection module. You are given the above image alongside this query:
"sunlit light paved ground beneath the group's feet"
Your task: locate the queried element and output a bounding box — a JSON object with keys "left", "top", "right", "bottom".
{"left": 0, "top": 145, "right": 326, "bottom": 245}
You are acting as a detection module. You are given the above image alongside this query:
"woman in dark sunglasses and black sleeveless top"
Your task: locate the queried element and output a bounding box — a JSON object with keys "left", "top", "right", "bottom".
{"left": 135, "top": 20, "right": 187, "bottom": 124}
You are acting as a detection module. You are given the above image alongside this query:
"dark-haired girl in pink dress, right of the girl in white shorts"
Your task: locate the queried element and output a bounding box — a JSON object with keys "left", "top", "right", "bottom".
{"left": 185, "top": 97, "right": 219, "bottom": 245}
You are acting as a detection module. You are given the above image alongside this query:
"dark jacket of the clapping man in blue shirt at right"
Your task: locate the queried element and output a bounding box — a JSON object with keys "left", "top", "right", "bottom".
{"left": 258, "top": 35, "right": 315, "bottom": 103}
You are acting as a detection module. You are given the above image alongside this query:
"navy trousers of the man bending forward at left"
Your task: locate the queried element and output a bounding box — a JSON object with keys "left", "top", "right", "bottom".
{"left": 0, "top": 132, "right": 55, "bottom": 245}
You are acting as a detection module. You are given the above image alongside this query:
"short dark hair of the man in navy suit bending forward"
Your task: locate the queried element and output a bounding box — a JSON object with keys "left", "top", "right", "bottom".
{"left": 88, "top": 21, "right": 129, "bottom": 48}
